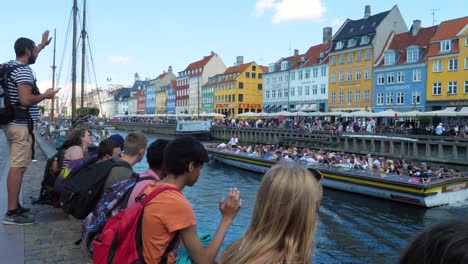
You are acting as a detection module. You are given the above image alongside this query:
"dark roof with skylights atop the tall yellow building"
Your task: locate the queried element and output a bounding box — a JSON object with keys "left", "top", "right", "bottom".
{"left": 331, "top": 7, "right": 391, "bottom": 51}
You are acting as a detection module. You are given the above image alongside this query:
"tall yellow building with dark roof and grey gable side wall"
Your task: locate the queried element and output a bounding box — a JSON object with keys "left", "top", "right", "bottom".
{"left": 328, "top": 6, "right": 408, "bottom": 111}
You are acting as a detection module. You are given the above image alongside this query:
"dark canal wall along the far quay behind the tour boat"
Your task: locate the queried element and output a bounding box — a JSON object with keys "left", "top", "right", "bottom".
{"left": 109, "top": 123, "right": 468, "bottom": 166}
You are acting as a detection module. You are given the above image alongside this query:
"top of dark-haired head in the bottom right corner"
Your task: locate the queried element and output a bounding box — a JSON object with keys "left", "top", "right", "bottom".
{"left": 399, "top": 219, "right": 468, "bottom": 264}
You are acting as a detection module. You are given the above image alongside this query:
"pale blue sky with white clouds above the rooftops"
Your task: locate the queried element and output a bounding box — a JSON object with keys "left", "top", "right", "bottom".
{"left": 0, "top": 0, "right": 468, "bottom": 100}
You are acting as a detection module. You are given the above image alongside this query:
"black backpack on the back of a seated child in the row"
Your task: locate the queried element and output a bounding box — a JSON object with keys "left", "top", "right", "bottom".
{"left": 60, "top": 159, "right": 132, "bottom": 219}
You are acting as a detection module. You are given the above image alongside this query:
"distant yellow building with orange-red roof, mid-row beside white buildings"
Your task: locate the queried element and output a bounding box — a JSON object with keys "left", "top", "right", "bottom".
{"left": 212, "top": 56, "right": 268, "bottom": 117}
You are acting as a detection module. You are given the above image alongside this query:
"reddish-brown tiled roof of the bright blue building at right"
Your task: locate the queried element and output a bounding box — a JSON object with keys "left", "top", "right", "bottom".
{"left": 382, "top": 26, "right": 437, "bottom": 65}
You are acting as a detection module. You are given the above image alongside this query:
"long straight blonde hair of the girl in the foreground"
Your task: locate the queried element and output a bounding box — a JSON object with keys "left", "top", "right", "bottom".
{"left": 221, "top": 163, "right": 322, "bottom": 264}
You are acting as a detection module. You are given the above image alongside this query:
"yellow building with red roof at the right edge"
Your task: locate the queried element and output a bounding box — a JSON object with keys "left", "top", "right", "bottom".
{"left": 426, "top": 17, "right": 468, "bottom": 110}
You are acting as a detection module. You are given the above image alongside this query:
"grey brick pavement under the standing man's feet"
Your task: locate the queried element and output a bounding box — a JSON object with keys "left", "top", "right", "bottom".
{"left": 0, "top": 132, "right": 92, "bottom": 263}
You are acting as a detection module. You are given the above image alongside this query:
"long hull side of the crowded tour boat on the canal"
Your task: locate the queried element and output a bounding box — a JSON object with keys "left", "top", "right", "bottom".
{"left": 207, "top": 148, "right": 468, "bottom": 207}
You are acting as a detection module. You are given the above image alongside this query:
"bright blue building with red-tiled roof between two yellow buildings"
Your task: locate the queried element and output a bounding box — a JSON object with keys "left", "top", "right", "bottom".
{"left": 372, "top": 20, "right": 437, "bottom": 112}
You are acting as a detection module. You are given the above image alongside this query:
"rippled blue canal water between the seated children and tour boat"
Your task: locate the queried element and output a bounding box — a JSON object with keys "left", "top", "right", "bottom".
{"left": 119, "top": 131, "right": 468, "bottom": 264}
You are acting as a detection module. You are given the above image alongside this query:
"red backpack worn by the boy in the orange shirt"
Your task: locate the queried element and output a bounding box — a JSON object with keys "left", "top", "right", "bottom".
{"left": 93, "top": 186, "right": 180, "bottom": 264}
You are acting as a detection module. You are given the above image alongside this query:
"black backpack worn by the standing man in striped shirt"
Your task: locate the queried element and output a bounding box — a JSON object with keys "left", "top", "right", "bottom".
{"left": 0, "top": 64, "right": 31, "bottom": 125}
